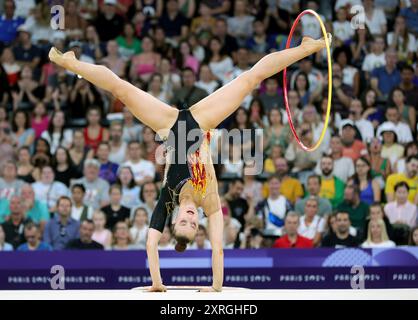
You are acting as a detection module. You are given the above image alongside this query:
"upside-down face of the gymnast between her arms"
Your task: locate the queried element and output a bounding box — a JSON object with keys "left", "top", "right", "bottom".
{"left": 173, "top": 203, "right": 199, "bottom": 240}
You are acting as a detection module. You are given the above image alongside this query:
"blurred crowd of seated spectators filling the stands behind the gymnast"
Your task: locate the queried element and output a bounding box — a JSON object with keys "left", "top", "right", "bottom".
{"left": 0, "top": 0, "right": 418, "bottom": 251}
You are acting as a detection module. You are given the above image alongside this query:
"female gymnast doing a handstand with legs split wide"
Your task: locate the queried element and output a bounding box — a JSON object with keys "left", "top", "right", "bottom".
{"left": 49, "top": 34, "right": 331, "bottom": 292}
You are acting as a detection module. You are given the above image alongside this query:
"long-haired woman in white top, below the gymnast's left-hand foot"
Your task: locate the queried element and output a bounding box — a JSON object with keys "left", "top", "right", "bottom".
{"left": 41, "top": 110, "right": 73, "bottom": 154}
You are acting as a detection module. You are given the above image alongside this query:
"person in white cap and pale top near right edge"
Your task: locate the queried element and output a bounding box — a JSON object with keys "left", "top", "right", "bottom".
{"left": 376, "top": 122, "right": 404, "bottom": 166}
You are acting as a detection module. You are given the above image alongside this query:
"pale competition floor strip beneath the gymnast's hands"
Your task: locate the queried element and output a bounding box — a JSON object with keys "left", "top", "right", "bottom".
{"left": 0, "top": 287, "right": 418, "bottom": 300}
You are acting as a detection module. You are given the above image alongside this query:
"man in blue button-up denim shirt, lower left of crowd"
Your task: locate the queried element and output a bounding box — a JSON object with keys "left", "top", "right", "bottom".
{"left": 43, "top": 197, "right": 80, "bottom": 250}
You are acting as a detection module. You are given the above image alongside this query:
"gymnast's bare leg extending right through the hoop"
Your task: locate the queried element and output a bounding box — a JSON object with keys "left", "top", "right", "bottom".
{"left": 190, "top": 34, "right": 331, "bottom": 130}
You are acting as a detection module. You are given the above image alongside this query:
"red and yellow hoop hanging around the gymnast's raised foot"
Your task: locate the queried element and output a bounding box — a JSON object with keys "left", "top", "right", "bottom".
{"left": 283, "top": 9, "right": 332, "bottom": 152}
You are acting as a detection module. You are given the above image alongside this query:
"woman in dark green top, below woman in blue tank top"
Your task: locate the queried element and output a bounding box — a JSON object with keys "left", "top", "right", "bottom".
{"left": 337, "top": 181, "right": 369, "bottom": 236}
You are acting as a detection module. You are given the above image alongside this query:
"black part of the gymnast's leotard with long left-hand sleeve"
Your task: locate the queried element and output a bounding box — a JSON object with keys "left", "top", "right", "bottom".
{"left": 150, "top": 109, "right": 204, "bottom": 232}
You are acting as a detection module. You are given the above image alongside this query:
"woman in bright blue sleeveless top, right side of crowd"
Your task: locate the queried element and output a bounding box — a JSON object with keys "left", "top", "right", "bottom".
{"left": 350, "top": 157, "right": 381, "bottom": 205}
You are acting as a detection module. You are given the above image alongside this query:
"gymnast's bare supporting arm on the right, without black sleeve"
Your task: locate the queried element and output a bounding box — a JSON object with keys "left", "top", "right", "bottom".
{"left": 208, "top": 210, "right": 224, "bottom": 291}
